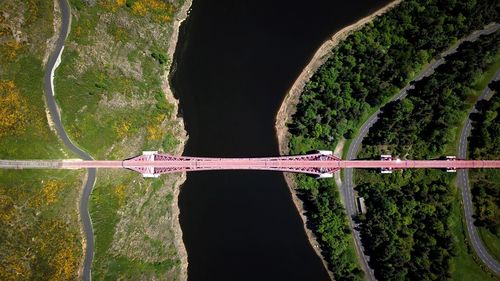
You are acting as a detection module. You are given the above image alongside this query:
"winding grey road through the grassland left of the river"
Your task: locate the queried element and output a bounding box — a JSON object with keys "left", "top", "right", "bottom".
{"left": 43, "top": 0, "right": 96, "bottom": 281}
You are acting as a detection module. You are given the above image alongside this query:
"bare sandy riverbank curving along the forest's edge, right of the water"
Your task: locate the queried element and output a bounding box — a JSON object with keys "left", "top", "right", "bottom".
{"left": 275, "top": 0, "right": 401, "bottom": 280}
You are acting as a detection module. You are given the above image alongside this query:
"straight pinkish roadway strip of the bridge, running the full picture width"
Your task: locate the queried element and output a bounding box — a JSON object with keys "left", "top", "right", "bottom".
{"left": 0, "top": 158, "right": 500, "bottom": 171}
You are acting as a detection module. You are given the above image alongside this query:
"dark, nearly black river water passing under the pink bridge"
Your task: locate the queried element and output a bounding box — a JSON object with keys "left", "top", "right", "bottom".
{"left": 171, "top": 0, "right": 387, "bottom": 281}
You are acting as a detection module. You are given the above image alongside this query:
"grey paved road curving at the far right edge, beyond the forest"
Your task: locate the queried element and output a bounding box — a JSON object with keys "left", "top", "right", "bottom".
{"left": 457, "top": 70, "right": 500, "bottom": 275}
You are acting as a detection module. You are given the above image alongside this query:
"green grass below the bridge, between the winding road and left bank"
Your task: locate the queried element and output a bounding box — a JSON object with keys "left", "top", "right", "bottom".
{"left": 90, "top": 171, "right": 180, "bottom": 280}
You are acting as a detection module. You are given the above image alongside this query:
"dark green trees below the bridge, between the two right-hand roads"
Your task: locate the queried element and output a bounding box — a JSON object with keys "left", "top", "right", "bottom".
{"left": 357, "top": 167, "right": 455, "bottom": 280}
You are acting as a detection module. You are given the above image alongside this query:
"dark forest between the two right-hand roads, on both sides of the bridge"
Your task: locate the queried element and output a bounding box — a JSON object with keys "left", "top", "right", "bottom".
{"left": 356, "top": 31, "right": 500, "bottom": 280}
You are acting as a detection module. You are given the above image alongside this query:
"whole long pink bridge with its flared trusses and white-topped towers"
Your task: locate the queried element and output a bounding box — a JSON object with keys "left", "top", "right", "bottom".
{"left": 0, "top": 151, "right": 500, "bottom": 178}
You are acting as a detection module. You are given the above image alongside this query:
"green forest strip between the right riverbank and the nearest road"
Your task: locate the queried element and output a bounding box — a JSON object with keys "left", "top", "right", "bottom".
{"left": 288, "top": 0, "right": 498, "bottom": 280}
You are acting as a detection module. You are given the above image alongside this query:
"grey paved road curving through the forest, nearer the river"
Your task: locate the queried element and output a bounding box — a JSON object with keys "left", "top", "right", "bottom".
{"left": 341, "top": 23, "right": 500, "bottom": 280}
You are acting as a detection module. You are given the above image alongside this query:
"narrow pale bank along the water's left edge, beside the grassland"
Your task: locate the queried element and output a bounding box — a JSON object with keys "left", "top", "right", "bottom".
{"left": 166, "top": 0, "right": 192, "bottom": 280}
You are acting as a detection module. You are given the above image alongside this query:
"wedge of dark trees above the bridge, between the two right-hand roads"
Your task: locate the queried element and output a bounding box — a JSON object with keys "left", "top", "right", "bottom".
{"left": 361, "top": 32, "right": 500, "bottom": 159}
